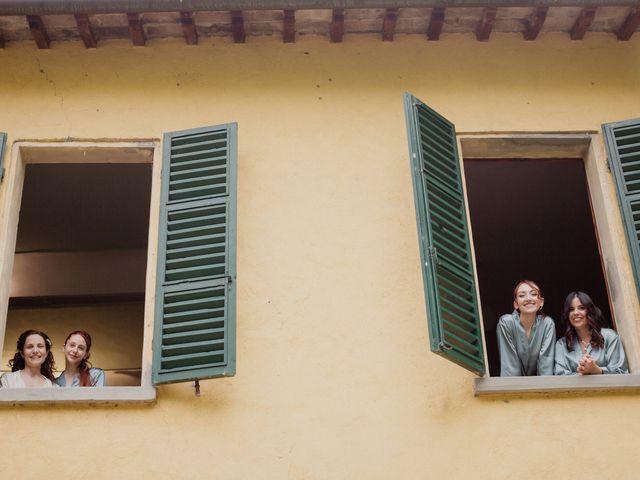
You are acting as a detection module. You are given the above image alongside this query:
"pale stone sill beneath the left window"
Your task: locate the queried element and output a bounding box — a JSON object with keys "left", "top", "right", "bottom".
{"left": 0, "top": 387, "right": 156, "bottom": 407}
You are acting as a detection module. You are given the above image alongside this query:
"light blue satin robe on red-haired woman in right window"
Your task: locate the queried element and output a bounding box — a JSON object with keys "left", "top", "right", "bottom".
{"left": 496, "top": 311, "right": 556, "bottom": 377}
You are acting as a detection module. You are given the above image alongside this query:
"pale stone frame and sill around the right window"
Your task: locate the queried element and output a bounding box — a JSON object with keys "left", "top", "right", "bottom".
{"left": 458, "top": 132, "right": 640, "bottom": 396}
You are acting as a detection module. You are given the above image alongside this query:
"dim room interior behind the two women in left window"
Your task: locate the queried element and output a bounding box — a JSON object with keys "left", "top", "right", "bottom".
{"left": 2, "top": 163, "right": 151, "bottom": 386}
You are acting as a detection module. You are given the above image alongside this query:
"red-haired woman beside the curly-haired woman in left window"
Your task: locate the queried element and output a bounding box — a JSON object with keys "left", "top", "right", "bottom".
{"left": 55, "top": 330, "right": 105, "bottom": 387}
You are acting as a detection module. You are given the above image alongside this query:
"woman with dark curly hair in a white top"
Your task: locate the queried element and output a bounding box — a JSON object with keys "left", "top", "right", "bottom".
{"left": 0, "top": 330, "right": 55, "bottom": 388}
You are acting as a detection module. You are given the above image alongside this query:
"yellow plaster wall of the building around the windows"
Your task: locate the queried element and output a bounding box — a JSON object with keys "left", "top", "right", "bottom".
{"left": 0, "top": 34, "right": 640, "bottom": 479}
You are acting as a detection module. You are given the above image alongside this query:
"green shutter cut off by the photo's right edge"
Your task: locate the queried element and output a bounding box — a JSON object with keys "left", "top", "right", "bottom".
{"left": 602, "top": 119, "right": 640, "bottom": 295}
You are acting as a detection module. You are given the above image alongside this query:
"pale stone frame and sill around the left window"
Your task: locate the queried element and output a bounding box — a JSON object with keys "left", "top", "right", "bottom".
{"left": 0, "top": 140, "right": 162, "bottom": 406}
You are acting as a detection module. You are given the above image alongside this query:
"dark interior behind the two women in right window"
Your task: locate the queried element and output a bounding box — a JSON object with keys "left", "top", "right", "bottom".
{"left": 464, "top": 159, "right": 613, "bottom": 376}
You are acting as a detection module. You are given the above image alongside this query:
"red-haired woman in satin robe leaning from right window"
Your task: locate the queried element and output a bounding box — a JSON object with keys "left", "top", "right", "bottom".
{"left": 496, "top": 280, "right": 556, "bottom": 377}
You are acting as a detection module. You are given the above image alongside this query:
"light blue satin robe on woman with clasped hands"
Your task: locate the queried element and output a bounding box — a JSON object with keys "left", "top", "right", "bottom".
{"left": 554, "top": 328, "right": 629, "bottom": 375}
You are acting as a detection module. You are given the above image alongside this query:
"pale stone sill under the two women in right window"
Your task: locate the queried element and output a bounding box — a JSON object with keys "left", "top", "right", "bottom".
{"left": 473, "top": 374, "right": 640, "bottom": 397}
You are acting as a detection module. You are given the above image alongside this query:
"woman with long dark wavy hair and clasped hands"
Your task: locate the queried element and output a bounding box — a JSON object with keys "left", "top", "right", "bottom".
{"left": 554, "top": 292, "right": 629, "bottom": 375}
